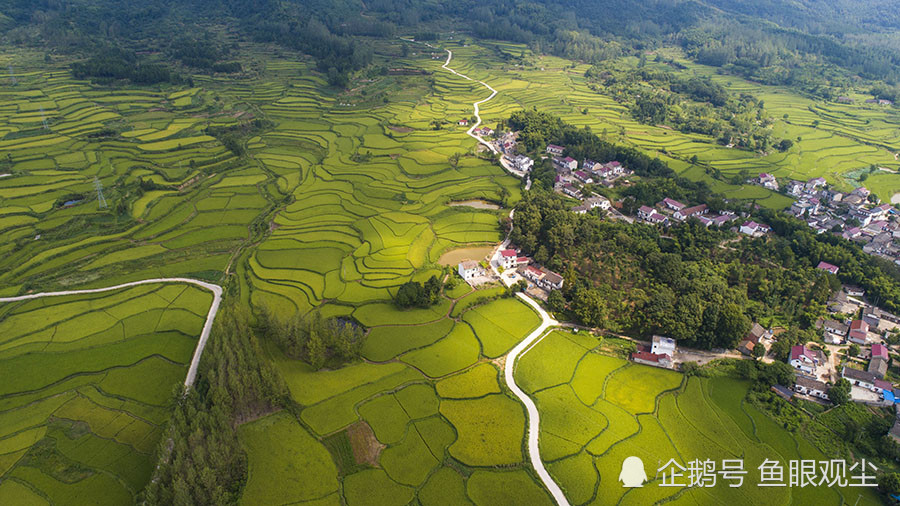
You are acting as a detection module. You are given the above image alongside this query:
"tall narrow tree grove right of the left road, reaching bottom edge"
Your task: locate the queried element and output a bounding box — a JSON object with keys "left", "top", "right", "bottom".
{"left": 143, "top": 306, "right": 287, "bottom": 506}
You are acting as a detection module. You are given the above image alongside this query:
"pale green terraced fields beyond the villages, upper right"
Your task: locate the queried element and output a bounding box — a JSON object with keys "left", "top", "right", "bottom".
{"left": 447, "top": 41, "right": 900, "bottom": 204}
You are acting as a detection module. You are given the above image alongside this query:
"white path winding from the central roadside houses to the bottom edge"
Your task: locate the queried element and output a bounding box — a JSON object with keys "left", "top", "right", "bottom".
{"left": 503, "top": 293, "right": 569, "bottom": 506}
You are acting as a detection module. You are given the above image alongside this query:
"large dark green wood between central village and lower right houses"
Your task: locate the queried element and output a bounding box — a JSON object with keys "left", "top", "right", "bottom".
{"left": 511, "top": 192, "right": 856, "bottom": 348}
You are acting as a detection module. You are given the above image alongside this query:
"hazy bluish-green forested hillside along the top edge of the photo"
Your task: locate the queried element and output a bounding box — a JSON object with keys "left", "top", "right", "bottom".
{"left": 0, "top": 0, "right": 900, "bottom": 92}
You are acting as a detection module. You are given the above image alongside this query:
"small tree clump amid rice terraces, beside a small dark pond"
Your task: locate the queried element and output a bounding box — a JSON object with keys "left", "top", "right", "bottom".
{"left": 258, "top": 307, "right": 363, "bottom": 370}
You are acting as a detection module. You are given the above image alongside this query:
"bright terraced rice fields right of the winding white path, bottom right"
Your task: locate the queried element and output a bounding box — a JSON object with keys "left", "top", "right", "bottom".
{"left": 516, "top": 331, "right": 880, "bottom": 505}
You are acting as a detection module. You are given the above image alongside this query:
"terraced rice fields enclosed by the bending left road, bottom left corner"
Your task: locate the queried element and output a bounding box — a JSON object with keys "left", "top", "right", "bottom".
{"left": 0, "top": 285, "right": 212, "bottom": 504}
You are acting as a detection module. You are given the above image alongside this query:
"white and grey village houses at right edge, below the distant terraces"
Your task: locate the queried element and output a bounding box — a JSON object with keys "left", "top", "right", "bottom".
{"left": 753, "top": 174, "right": 900, "bottom": 264}
